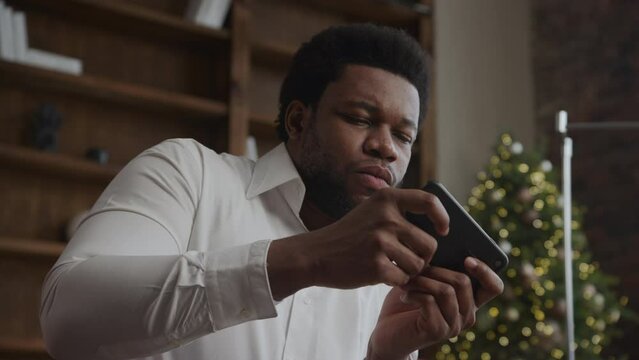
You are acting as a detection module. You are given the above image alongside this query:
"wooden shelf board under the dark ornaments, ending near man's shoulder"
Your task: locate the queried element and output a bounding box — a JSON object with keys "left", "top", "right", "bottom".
{"left": 0, "top": 144, "right": 120, "bottom": 183}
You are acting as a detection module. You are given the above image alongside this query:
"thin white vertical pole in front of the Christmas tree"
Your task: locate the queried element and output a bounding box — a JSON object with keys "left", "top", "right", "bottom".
{"left": 556, "top": 110, "right": 575, "bottom": 360}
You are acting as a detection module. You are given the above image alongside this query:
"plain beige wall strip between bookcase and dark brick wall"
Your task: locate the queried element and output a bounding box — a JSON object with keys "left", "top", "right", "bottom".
{"left": 434, "top": 0, "right": 534, "bottom": 202}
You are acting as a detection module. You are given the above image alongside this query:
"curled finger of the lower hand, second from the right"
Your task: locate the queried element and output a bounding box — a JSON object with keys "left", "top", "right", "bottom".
{"left": 422, "top": 266, "right": 477, "bottom": 329}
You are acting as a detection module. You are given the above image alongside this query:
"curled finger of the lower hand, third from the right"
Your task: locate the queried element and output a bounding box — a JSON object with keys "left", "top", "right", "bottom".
{"left": 403, "top": 276, "right": 461, "bottom": 328}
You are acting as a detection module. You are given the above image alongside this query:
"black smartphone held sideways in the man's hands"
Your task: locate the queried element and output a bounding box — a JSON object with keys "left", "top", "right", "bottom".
{"left": 406, "top": 181, "right": 508, "bottom": 280}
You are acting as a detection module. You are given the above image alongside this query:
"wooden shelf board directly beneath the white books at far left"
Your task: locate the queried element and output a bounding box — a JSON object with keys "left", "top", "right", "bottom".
{"left": 0, "top": 61, "right": 228, "bottom": 118}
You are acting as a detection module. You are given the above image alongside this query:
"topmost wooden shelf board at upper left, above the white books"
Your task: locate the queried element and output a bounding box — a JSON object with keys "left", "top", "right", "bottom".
{"left": 15, "top": 0, "right": 230, "bottom": 48}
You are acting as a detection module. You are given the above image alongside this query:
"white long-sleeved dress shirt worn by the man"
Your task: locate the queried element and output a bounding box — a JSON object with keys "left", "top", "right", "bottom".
{"left": 40, "top": 139, "right": 412, "bottom": 360}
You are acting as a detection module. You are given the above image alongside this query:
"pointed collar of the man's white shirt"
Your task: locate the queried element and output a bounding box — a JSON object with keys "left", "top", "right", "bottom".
{"left": 246, "top": 143, "right": 306, "bottom": 213}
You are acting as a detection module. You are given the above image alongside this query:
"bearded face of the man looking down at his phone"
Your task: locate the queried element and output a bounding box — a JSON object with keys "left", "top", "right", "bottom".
{"left": 297, "top": 65, "right": 420, "bottom": 218}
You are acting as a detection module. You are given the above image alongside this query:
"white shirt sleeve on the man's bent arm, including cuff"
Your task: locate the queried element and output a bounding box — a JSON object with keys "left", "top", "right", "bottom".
{"left": 40, "top": 140, "right": 277, "bottom": 359}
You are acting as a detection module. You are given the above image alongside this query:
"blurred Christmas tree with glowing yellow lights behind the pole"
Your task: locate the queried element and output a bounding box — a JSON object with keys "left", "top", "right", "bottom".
{"left": 435, "top": 134, "right": 631, "bottom": 360}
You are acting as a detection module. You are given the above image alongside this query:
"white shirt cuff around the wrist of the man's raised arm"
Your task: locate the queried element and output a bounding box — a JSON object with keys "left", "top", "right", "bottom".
{"left": 206, "top": 240, "right": 277, "bottom": 331}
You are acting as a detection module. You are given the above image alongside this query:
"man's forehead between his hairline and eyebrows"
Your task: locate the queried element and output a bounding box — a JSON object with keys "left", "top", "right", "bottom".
{"left": 322, "top": 65, "right": 420, "bottom": 122}
